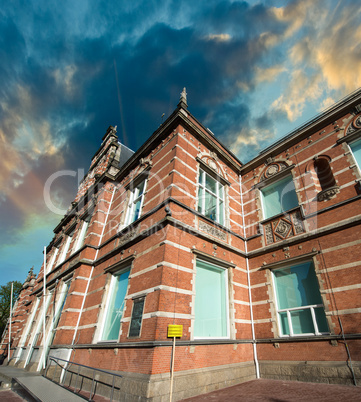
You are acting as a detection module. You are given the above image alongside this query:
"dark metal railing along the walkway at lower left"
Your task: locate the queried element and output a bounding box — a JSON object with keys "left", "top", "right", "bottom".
{"left": 44, "top": 356, "right": 123, "bottom": 402}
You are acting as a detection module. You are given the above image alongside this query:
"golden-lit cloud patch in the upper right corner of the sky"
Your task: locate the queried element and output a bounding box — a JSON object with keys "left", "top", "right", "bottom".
{"left": 266, "top": 2, "right": 361, "bottom": 121}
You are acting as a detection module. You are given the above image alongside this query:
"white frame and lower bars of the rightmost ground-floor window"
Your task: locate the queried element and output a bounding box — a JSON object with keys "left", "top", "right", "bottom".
{"left": 272, "top": 261, "right": 330, "bottom": 338}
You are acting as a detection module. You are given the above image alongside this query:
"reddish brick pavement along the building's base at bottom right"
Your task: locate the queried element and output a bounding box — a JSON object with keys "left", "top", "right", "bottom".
{"left": 184, "top": 379, "right": 361, "bottom": 402}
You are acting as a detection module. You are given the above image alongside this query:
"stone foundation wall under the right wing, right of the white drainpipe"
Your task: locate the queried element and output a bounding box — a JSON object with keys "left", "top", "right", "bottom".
{"left": 259, "top": 361, "right": 361, "bottom": 385}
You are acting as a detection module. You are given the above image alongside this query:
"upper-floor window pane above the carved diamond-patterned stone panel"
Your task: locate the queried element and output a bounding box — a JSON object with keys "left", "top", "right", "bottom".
{"left": 262, "top": 176, "right": 298, "bottom": 219}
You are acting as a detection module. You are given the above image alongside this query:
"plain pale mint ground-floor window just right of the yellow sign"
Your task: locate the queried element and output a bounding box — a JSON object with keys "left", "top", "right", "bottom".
{"left": 194, "top": 260, "right": 229, "bottom": 338}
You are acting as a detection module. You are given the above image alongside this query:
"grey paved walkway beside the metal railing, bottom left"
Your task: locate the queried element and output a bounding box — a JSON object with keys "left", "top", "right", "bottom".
{"left": 0, "top": 366, "right": 84, "bottom": 402}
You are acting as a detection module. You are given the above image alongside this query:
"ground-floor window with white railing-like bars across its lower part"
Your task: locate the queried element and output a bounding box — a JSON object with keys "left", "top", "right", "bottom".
{"left": 273, "top": 262, "right": 329, "bottom": 336}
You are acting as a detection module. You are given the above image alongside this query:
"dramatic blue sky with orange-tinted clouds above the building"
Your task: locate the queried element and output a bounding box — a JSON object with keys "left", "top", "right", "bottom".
{"left": 0, "top": 0, "right": 361, "bottom": 285}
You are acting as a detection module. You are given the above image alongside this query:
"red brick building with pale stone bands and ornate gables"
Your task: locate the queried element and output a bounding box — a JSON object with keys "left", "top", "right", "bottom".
{"left": 0, "top": 90, "right": 361, "bottom": 401}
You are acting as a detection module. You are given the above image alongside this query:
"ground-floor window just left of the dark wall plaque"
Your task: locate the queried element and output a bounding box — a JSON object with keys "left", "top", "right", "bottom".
{"left": 101, "top": 269, "right": 130, "bottom": 341}
